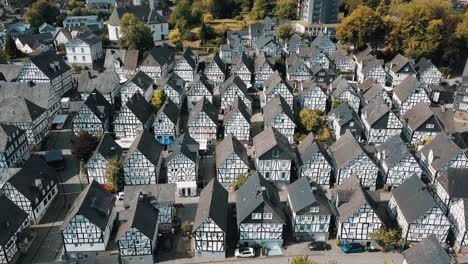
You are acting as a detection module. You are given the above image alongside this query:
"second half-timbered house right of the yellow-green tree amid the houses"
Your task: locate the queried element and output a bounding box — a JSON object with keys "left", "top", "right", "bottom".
{"left": 361, "top": 98, "right": 403, "bottom": 144}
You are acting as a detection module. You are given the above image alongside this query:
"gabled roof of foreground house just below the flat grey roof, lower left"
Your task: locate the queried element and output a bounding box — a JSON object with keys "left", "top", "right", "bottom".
{"left": 115, "top": 196, "right": 159, "bottom": 240}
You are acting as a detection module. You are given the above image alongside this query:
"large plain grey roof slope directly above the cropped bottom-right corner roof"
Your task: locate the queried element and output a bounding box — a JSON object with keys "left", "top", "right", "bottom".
{"left": 392, "top": 174, "right": 437, "bottom": 224}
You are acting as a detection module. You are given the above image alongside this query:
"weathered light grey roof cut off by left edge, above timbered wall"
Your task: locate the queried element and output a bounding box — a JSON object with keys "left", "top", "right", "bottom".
{"left": 0, "top": 97, "right": 47, "bottom": 123}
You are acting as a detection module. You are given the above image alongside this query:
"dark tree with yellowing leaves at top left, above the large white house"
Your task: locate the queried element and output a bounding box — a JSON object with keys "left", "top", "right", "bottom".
{"left": 24, "top": 0, "right": 60, "bottom": 28}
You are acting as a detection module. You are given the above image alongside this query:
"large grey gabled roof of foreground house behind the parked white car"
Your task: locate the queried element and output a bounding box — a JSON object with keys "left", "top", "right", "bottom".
{"left": 236, "top": 172, "right": 286, "bottom": 225}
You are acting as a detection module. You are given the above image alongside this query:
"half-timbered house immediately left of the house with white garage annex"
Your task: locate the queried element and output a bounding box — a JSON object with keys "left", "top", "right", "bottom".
{"left": 123, "top": 129, "right": 162, "bottom": 185}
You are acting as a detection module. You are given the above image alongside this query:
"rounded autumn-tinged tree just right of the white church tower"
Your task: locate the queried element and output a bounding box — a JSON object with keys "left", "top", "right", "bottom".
{"left": 120, "top": 13, "right": 154, "bottom": 53}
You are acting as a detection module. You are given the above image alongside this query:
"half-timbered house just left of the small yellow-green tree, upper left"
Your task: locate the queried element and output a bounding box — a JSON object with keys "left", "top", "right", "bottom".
{"left": 120, "top": 71, "right": 154, "bottom": 106}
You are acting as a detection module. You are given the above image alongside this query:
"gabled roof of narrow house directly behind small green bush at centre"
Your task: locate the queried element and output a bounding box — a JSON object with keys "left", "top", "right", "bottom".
{"left": 215, "top": 134, "right": 249, "bottom": 167}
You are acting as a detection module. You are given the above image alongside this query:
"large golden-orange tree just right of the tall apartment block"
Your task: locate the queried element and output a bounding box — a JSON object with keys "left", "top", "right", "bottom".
{"left": 336, "top": 6, "right": 388, "bottom": 50}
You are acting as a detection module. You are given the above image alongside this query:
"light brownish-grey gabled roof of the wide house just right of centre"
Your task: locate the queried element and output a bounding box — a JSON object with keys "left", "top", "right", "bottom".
{"left": 253, "top": 127, "right": 295, "bottom": 159}
